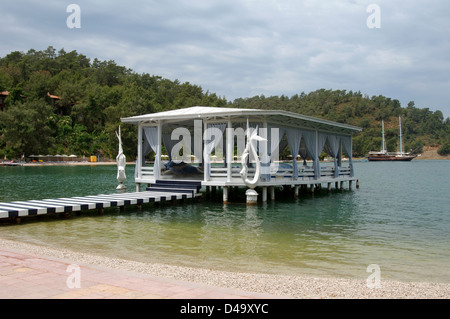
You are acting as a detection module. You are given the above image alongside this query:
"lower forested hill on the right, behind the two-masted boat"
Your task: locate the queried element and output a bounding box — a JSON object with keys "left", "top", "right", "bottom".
{"left": 232, "top": 89, "right": 450, "bottom": 156}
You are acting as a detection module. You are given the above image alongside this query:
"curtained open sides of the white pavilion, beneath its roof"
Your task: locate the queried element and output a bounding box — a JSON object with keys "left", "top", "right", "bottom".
{"left": 136, "top": 120, "right": 353, "bottom": 183}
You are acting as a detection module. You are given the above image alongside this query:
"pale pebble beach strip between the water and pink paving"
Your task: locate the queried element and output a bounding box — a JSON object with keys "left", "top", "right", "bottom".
{"left": 0, "top": 237, "right": 450, "bottom": 299}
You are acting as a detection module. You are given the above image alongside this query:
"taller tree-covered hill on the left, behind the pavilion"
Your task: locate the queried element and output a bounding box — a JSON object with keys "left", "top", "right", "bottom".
{"left": 0, "top": 47, "right": 227, "bottom": 158}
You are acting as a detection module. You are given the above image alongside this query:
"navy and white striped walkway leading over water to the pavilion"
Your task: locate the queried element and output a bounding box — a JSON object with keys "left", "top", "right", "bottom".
{"left": 0, "top": 184, "right": 199, "bottom": 219}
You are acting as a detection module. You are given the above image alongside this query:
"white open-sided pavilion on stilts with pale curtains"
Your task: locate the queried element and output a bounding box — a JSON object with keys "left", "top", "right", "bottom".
{"left": 121, "top": 106, "right": 362, "bottom": 202}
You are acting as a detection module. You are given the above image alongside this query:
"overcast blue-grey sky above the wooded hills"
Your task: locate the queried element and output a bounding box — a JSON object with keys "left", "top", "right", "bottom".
{"left": 0, "top": 0, "right": 450, "bottom": 117}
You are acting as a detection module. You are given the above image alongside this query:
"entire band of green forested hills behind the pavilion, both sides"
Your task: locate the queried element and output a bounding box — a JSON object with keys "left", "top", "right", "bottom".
{"left": 0, "top": 47, "right": 450, "bottom": 159}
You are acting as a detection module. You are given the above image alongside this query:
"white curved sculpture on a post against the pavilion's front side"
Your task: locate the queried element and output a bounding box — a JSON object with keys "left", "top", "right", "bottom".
{"left": 240, "top": 119, "right": 266, "bottom": 204}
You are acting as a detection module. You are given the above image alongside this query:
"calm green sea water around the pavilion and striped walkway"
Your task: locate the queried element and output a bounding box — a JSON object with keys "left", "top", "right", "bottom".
{"left": 0, "top": 160, "right": 450, "bottom": 282}
